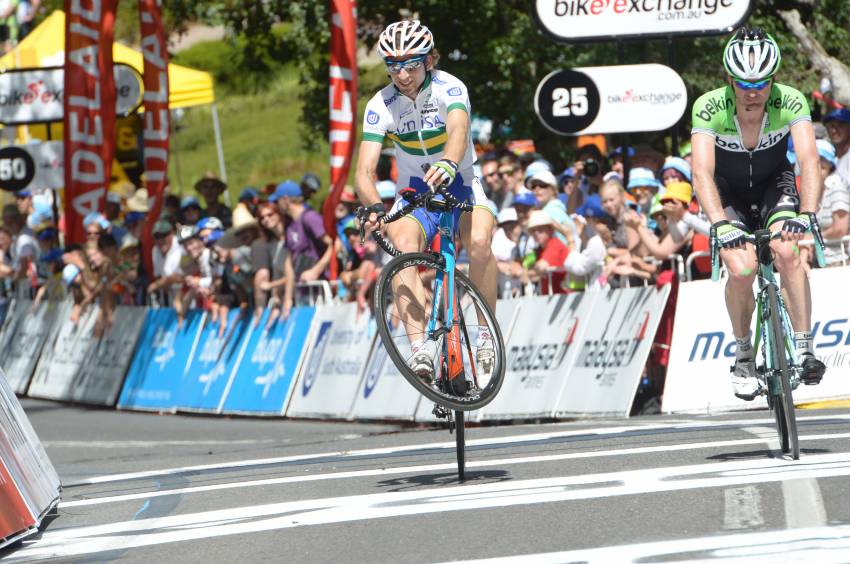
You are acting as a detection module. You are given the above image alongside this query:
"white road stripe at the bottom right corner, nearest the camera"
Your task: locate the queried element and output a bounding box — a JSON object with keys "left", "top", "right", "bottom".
{"left": 444, "top": 525, "right": 850, "bottom": 564}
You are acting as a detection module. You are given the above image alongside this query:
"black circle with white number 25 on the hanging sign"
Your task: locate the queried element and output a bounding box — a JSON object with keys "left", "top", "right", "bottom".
{"left": 534, "top": 70, "right": 599, "bottom": 135}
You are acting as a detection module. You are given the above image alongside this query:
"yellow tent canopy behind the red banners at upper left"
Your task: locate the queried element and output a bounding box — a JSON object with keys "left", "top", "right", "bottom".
{"left": 0, "top": 10, "right": 215, "bottom": 110}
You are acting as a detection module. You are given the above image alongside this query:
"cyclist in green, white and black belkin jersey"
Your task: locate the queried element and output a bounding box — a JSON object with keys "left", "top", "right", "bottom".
{"left": 691, "top": 27, "right": 825, "bottom": 401}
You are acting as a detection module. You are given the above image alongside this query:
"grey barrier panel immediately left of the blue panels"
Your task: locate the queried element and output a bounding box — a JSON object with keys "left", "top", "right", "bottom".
{"left": 71, "top": 306, "right": 147, "bottom": 405}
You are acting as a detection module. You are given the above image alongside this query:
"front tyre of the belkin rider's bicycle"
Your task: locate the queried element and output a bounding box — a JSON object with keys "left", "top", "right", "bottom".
{"left": 767, "top": 284, "right": 800, "bottom": 460}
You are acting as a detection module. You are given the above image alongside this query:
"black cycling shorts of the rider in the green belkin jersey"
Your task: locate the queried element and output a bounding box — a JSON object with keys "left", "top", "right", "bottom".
{"left": 714, "top": 163, "right": 800, "bottom": 232}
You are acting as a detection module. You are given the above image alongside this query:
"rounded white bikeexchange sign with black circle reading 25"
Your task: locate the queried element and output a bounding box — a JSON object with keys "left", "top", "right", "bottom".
{"left": 534, "top": 64, "right": 688, "bottom": 135}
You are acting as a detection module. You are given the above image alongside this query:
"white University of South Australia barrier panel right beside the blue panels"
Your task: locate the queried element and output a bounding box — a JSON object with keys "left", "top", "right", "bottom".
{"left": 286, "top": 303, "right": 372, "bottom": 418}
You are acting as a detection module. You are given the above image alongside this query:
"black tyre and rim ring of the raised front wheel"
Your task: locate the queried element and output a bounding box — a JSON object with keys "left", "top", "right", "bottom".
{"left": 374, "top": 253, "right": 506, "bottom": 411}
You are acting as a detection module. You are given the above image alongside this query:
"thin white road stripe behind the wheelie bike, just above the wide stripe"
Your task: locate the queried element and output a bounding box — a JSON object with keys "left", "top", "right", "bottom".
{"left": 59, "top": 433, "right": 850, "bottom": 509}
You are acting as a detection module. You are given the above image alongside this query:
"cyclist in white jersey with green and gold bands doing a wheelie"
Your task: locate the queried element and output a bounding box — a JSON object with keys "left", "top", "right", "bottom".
{"left": 357, "top": 20, "right": 498, "bottom": 378}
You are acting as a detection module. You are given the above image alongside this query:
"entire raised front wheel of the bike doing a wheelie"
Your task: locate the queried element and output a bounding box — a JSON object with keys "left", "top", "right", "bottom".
{"left": 375, "top": 253, "right": 505, "bottom": 411}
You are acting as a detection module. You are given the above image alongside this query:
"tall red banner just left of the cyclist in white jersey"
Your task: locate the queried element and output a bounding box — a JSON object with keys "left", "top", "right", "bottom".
{"left": 322, "top": 0, "right": 357, "bottom": 278}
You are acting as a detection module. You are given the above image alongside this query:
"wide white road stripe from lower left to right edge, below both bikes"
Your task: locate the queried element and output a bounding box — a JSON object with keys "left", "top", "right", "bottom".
{"left": 13, "top": 453, "right": 850, "bottom": 562}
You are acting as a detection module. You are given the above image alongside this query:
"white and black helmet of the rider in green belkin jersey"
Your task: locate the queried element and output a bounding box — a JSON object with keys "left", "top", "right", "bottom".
{"left": 723, "top": 27, "right": 782, "bottom": 81}
